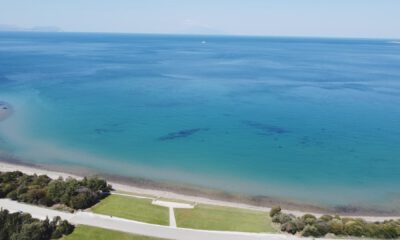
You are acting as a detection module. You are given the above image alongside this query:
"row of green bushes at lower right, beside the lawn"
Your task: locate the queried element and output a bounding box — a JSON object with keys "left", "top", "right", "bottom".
{"left": 270, "top": 207, "right": 400, "bottom": 239}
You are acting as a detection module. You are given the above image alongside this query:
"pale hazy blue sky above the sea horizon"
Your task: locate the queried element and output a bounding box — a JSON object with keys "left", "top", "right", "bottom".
{"left": 0, "top": 0, "right": 400, "bottom": 38}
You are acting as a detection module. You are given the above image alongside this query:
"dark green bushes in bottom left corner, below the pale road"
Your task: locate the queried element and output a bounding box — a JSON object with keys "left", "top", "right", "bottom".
{"left": 0, "top": 210, "right": 74, "bottom": 240}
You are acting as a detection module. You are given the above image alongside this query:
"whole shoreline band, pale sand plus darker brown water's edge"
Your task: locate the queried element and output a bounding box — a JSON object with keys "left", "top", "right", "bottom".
{"left": 0, "top": 159, "right": 400, "bottom": 221}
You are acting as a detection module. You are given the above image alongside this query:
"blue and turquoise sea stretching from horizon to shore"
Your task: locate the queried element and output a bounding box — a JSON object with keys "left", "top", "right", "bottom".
{"left": 0, "top": 33, "right": 400, "bottom": 210}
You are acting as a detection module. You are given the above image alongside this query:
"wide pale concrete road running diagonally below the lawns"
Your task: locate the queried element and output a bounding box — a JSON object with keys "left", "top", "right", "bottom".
{"left": 0, "top": 199, "right": 302, "bottom": 240}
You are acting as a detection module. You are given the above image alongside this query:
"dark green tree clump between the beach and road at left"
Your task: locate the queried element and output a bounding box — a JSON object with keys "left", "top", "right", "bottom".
{"left": 0, "top": 171, "right": 111, "bottom": 210}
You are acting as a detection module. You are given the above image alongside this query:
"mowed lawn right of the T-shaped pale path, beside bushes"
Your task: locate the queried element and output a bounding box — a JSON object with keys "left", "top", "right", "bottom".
{"left": 175, "top": 204, "right": 276, "bottom": 233}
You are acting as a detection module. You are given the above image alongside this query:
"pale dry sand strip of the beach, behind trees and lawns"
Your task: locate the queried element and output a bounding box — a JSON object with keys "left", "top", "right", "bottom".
{"left": 0, "top": 160, "right": 400, "bottom": 221}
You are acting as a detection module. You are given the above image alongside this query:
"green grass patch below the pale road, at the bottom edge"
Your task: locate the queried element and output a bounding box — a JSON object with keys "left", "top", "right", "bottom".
{"left": 63, "top": 225, "right": 166, "bottom": 240}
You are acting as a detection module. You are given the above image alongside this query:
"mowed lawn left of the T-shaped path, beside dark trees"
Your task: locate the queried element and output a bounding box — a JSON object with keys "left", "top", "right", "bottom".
{"left": 92, "top": 195, "right": 169, "bottom": 225}
